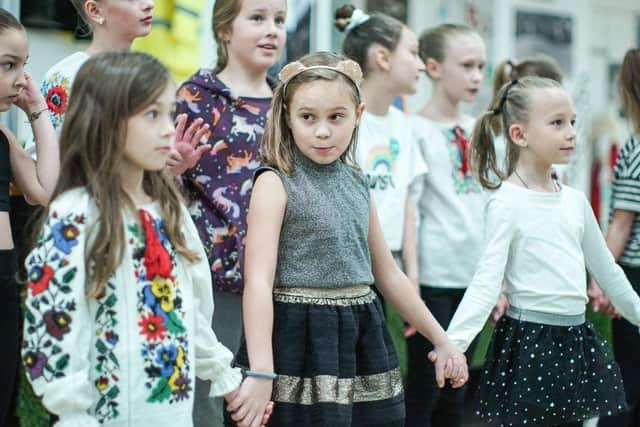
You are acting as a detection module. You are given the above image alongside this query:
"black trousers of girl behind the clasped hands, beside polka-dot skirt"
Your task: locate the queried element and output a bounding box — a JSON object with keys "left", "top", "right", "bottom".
{"left": 405, "top": 285, "right": 475, "bottom": 427}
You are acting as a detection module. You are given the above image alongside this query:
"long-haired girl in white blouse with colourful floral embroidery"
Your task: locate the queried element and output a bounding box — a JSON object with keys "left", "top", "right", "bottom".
{"left": 22, "top": 52, "right": 241, "bottom": 427}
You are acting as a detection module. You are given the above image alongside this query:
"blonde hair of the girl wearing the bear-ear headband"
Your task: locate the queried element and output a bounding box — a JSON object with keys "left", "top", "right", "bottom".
{"left": 261, "top": 52, "right": 360, "bottom": 174}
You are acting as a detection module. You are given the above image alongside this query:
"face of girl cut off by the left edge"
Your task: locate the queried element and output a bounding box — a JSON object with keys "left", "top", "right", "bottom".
{"left": 0, "top": 28, "right": 29, "bottom": 111}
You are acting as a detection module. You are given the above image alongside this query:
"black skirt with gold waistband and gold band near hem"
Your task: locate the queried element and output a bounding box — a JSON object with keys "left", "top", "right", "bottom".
{"left": 229, "top": 286, "right": 404, "bottom": 427}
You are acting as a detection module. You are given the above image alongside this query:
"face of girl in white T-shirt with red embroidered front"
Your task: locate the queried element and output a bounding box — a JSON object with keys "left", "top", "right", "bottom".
{"left": 430, "top": 33, "right": 487, "bottom": 102}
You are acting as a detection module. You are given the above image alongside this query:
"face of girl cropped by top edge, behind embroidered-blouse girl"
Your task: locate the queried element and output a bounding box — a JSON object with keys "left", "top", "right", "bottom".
{"left": 100, "top": 0, "right": 154, "bottom": 40}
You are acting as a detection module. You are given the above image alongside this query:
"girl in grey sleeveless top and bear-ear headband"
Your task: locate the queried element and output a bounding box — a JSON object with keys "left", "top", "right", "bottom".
{"left": 228, "top": 53, "right": 468, "bottom": 427}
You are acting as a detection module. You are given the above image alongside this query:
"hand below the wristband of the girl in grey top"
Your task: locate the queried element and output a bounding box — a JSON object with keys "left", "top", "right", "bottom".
{"left": 227, "top": 377, "right": 273, "bottom": 427}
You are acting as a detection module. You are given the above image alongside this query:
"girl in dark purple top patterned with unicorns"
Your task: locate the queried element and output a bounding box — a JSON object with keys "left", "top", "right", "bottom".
{"left": 172, "top": 0, "right": 286, "bottom": 427}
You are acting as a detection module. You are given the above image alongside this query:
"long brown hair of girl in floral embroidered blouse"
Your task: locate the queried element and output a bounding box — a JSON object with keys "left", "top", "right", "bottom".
{"left": 41, "top": 52, "right": 197, "bottom": 297}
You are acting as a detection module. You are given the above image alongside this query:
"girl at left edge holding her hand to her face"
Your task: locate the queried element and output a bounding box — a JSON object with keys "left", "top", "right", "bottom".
{"left": 0, "top": 8, "right": 60, "bottom": 425}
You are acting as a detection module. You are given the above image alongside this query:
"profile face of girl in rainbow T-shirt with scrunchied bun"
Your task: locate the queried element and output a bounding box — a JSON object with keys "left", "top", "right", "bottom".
{"left": 389, "top": 27, "right": 424, "bottom": 95}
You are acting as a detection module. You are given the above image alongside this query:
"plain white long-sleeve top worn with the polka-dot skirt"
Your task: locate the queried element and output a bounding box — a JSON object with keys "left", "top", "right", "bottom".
{"left": 447, "top": 182, "right": 640, "bottom": 350}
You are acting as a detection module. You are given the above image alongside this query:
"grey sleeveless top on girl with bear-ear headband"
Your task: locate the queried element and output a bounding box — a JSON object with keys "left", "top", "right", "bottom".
{"left": 254, "top": 152, "right": 373, "bottom": 288}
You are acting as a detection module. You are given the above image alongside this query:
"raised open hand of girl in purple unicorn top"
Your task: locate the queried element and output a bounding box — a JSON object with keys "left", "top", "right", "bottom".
{"left": 167, "top": 114, "right": 211, "bottom": 176}
